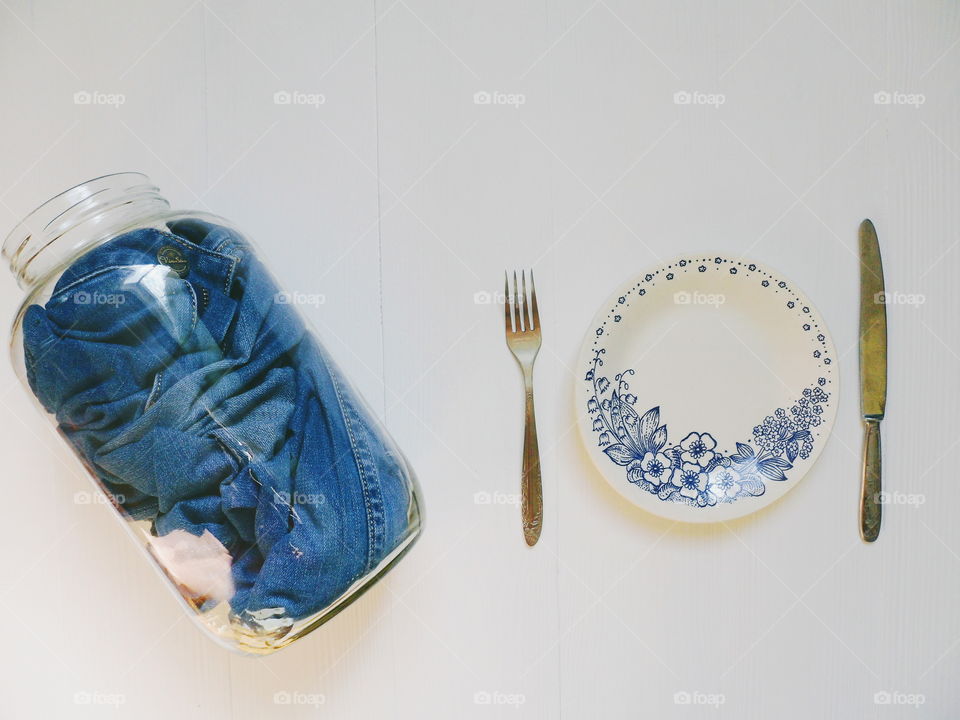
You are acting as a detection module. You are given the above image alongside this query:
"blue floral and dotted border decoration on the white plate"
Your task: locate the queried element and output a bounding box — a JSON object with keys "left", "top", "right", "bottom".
{"left": 584, "top": 257, "right": 832, "bottom": 508}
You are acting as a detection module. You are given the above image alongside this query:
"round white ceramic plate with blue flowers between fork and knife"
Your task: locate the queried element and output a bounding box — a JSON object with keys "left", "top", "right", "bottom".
{"left": 576, "top": 255, "right": 838, "bottom": 522}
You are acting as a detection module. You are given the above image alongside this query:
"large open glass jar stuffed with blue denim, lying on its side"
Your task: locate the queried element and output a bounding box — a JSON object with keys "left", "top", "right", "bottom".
{"left": 3, "top": 173, "right": 421, "bottom": 654}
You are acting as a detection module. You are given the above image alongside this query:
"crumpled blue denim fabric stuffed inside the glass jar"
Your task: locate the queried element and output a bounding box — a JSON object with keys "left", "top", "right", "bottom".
{"left": 23, "top": 219, "right": 411, "bottom": 619}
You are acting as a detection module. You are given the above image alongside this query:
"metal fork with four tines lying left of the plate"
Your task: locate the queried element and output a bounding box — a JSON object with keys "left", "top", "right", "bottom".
{"left": 503, "top": 269, "right": 543, "bottom": 546}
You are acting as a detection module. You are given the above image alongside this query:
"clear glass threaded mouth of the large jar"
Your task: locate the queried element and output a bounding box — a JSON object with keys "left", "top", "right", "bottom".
{"left": 0, "top": 172, "right": 169, "bottom": 286}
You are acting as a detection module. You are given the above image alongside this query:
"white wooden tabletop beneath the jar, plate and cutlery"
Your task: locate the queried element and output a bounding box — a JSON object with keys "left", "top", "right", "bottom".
{"left": 0, "top": 0, "right": 960, "bottom": 720}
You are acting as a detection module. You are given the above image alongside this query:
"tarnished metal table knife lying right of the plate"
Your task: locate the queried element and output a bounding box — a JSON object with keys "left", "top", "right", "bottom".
{"left": 860, "top": 220, "right": 887, "bottom": 542}
